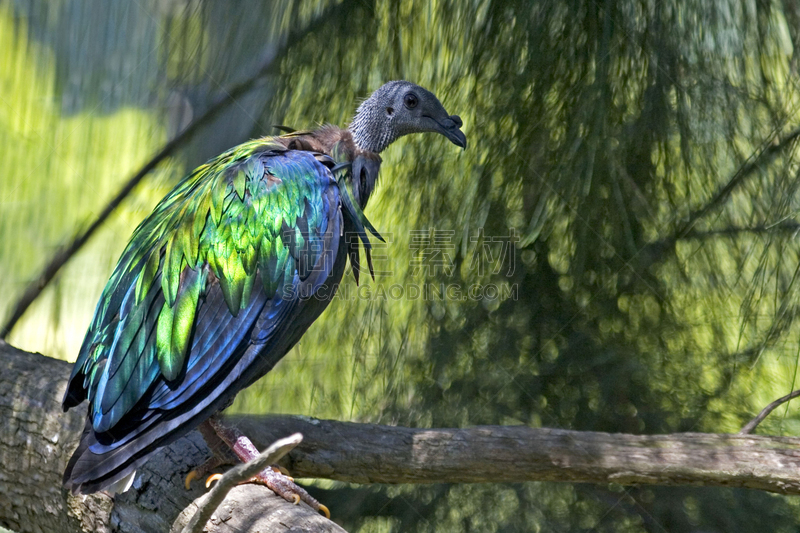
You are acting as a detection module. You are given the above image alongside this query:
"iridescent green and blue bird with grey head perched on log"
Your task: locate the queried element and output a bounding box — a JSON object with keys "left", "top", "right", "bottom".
{"left": 62, "top": 80, "right": 467, "bottom": 515}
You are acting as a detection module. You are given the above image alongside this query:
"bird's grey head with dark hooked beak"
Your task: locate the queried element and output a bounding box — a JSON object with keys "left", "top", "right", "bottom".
{"left": 349, "top": 81, "right": 467, "bottom": 153}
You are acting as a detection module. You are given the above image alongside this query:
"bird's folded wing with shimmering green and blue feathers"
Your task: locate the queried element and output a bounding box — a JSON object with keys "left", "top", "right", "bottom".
{"left": 63, "top": 135, "right": 342, "bottom": 434}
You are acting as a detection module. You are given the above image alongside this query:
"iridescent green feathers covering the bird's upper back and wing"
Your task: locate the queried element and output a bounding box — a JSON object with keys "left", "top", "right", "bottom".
{"left": 71, "top": 139, "right": 334, "bottom": 426}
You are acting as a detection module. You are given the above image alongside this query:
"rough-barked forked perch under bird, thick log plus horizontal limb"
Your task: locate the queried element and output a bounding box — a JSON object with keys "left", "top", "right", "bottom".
{"left": 0, "top": 341, "right": 800, "bottom": 532}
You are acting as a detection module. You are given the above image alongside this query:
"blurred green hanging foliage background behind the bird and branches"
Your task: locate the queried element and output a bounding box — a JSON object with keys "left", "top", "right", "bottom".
{"left": 0, "top": 0, "right": 800, "bottom": 532}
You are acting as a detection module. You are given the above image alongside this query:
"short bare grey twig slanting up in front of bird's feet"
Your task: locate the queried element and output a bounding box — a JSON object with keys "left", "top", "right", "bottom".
{"left": 181, "top": 433, "right": 303, "bottom": 533}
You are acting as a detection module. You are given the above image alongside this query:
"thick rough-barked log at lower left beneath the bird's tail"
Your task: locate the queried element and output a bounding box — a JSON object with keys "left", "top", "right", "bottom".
{"left": 0, "top": 341, "right": 344, "bottom": 533}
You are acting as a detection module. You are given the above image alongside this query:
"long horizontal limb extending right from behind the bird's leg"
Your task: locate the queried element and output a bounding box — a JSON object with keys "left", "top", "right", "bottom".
{"left": 230, "top": 417, "right": 800, "bottom": 494}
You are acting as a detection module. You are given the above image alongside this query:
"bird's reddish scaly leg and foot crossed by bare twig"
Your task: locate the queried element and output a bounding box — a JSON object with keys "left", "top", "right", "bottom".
{"left": 207, "top": 416, "right": 331, "bottom": 518}
